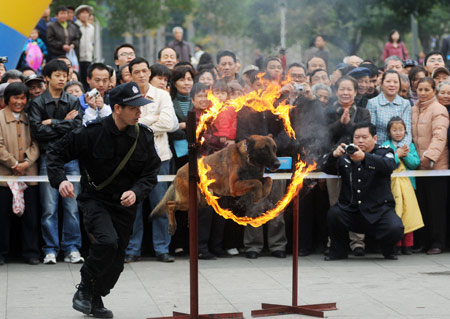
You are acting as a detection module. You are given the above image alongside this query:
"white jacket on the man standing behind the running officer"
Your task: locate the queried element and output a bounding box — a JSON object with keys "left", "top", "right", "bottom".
{"left": 139, "top": 84, "right": 178, "bottom": 161}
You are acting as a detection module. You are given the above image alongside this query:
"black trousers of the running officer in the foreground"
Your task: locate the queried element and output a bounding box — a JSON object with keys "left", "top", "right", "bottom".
{"left": 78, "top": 193, "right": 137, "bottom": 296}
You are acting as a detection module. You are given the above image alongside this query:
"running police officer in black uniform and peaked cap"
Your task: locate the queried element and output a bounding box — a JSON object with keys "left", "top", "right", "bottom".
{"left": 47, "top": 82, "right": 161, "bottom": 318}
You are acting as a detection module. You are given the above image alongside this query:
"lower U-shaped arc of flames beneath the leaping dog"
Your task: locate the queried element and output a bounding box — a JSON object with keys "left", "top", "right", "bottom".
{"left": 198, "top": 157, "right": 316, "bottom": 227}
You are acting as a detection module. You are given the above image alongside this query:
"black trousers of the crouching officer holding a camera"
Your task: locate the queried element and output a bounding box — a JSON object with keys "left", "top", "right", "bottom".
{"left": 327, "top": 205, "right": 404, "bottom": 258}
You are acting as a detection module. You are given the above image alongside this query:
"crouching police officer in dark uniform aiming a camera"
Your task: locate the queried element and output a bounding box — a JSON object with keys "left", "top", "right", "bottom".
{"left": 323, "top": 122, "right": 404, "bottom": 260}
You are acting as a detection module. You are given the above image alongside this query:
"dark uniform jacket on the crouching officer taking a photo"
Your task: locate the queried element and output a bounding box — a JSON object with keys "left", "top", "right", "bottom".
{"left": 322, "top": 144, "right": 397, "bottom": 224}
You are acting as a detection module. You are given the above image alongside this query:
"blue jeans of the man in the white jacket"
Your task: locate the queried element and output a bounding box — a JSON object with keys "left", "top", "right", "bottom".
{"left": 126, "top": 160, "right": 170, "bottom": 256}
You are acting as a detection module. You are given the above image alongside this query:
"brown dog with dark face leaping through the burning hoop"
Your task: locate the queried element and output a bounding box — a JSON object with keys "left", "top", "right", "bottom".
{"left": 150, "top": 135, "right": 280, "bottom": 235}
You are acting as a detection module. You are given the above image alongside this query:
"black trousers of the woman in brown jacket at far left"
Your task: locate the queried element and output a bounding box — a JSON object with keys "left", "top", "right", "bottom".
{"left": 0, "top": 186, "right": 40, "bottom": 259}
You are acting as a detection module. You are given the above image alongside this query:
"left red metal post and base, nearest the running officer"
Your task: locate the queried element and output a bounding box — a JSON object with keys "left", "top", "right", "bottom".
{"left": 148, "top": 111, "right": 244, "bottom": 319}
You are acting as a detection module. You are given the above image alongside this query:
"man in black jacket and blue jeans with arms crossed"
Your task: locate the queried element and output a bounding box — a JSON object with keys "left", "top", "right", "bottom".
{"left": 28, "top": 60, "right": 83, "bottom": 264}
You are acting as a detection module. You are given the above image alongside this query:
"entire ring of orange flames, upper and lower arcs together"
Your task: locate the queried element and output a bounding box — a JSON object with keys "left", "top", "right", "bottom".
{"left": 196, "top": 74, "right": 316, "bottom": 227}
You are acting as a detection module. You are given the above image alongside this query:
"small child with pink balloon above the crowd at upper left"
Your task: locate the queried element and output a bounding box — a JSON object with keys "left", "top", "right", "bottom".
{"left": 20, "top": 29, "right": 48, "bottom": 74}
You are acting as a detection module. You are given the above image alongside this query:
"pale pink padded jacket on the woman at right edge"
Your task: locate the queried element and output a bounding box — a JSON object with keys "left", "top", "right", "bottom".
{"left": 411, "top": 98, "right": 449, "bottom": 170}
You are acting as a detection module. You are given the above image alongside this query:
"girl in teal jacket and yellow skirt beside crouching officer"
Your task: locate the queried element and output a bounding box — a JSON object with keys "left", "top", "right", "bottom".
{"left": 383, "top": 116, "right": 424, "bottom": 255}
